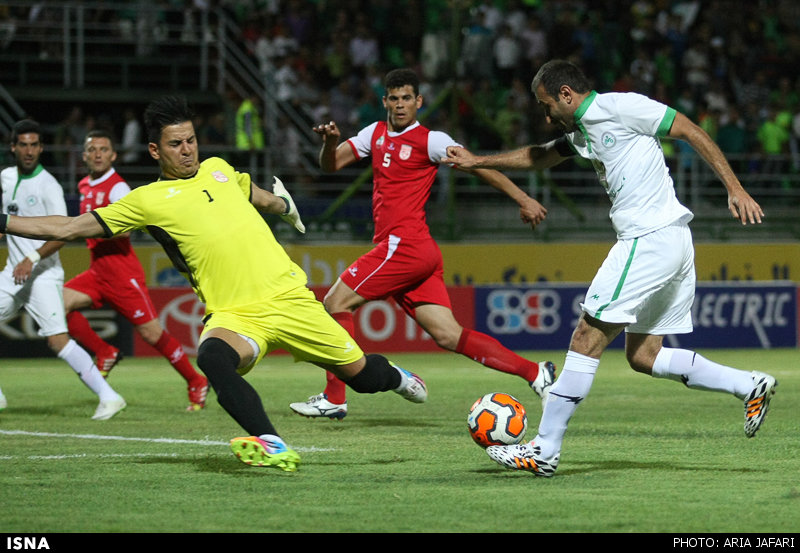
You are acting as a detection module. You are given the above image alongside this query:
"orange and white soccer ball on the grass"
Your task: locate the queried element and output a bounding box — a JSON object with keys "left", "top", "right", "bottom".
{"left": 467, "top": 392, "right": 528, "bottom": 447}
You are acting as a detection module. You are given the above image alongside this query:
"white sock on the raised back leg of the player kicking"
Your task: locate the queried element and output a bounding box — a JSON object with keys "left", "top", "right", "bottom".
{"left": 653, "top": 347, "right": 753, "bottom": 399}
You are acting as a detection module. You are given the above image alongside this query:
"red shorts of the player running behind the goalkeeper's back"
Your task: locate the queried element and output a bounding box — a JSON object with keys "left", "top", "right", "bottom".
{"left": 64, "top": 269, "right": 158, "bottom": 325}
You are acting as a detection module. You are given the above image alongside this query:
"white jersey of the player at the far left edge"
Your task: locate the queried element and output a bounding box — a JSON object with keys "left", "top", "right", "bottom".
{"left": 0, "top": 165, "right": 67, "bottom": 271}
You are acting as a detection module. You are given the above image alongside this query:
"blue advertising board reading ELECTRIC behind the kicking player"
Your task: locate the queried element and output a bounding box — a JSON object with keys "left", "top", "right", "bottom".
{"left": 475, "top": 282, "right": 798, "bottom": 350}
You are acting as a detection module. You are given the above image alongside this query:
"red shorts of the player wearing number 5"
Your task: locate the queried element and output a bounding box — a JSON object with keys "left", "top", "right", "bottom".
{"left": 339, "top": 235, "right": 451, "bottom": 316}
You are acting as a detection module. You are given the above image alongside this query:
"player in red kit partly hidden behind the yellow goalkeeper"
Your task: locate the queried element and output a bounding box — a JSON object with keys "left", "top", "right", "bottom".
{"left": 64, "top": 130, "right": 208, "bottom": 411}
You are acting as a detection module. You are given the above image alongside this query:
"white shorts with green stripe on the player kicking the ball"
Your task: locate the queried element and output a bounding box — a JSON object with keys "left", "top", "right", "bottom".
{"left": 581, "top": 224, "right": 696, "bottom": 335}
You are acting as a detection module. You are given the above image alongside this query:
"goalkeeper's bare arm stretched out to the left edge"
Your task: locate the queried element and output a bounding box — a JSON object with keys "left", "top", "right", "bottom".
{"left": 0, "top": 213, "right": 105, "bottom": 242}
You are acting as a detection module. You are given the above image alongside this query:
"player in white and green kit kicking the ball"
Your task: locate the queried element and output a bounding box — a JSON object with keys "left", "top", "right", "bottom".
{"left": 443, "top": 60, "right": 777, "bottom": 476}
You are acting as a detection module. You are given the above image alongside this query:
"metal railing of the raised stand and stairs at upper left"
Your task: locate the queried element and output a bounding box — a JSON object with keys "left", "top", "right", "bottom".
{"left": 0, "top": 0, "right": 315, "bottom": 175}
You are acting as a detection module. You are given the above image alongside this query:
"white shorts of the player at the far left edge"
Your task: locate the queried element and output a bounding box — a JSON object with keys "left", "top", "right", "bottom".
{"left": 0, "top": 266, "right": 67, "bottom": 336}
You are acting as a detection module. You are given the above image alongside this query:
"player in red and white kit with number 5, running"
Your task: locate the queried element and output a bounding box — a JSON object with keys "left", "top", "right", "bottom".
{"left": 290, "top": 69, "right": 555, "bottom": 419}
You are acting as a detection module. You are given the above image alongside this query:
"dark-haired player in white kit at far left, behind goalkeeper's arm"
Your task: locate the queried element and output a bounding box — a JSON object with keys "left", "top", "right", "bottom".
{"left": 0, "top": 119, "right": 125, "bottom": 420}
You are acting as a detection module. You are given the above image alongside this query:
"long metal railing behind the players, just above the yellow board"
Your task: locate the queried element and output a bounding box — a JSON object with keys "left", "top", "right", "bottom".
{"left": 34, "top": 139, "right": 800, "bottom": 241}
